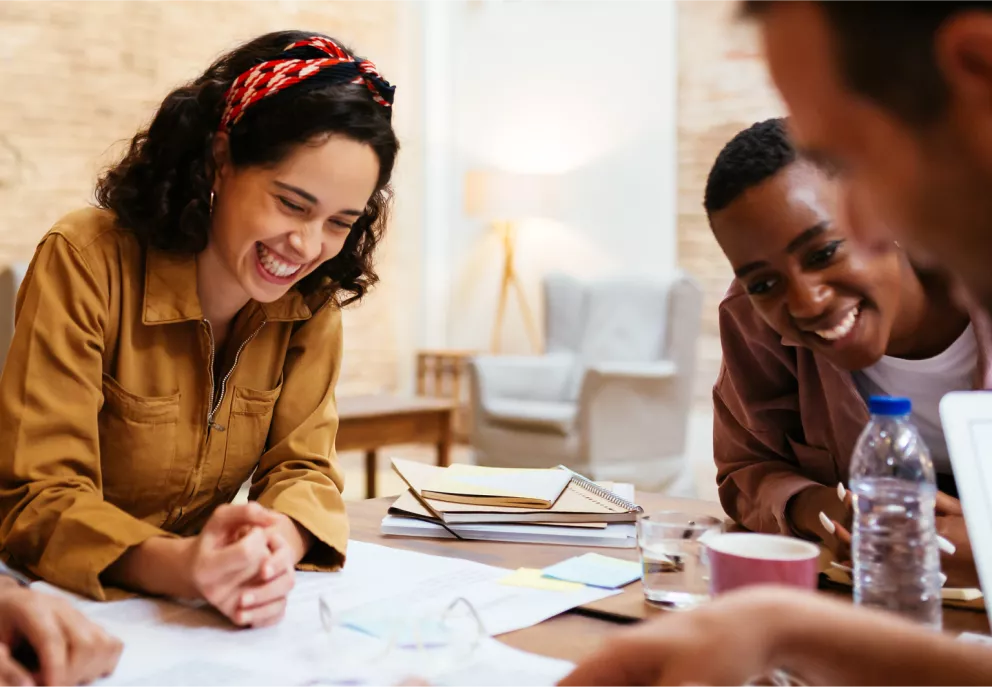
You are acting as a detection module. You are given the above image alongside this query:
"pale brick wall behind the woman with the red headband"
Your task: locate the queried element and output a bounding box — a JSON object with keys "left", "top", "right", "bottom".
{"left": 0, "top": 0, "right": 416, "bottom": 393}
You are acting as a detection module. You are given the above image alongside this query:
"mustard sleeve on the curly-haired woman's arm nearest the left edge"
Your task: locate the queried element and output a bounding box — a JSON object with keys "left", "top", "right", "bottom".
{"left": 0, "top": 232, "right": 172, "bottom": 600}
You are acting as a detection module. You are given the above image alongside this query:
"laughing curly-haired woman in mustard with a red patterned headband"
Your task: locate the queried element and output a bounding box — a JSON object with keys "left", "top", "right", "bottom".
{"left": 0, "top": 31, "right": 398, "bottom": 626}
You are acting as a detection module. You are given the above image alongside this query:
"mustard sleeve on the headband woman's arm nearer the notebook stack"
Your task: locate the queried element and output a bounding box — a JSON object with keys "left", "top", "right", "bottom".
{"left": 249, "top": 303, "right": 348, "bottom": 570}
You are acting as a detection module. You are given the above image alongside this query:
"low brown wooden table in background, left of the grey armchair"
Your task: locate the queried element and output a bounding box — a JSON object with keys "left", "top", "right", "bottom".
{"left": 335, "top": 395, "right": 456, "bottom": 500}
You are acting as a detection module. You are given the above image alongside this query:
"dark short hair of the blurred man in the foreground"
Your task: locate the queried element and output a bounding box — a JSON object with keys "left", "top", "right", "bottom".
{"left": 741, "top": 0, "right": 992, "bottom": 125}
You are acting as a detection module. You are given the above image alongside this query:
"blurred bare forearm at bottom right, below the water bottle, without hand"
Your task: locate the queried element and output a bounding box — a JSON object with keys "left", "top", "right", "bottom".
{"left": 770, "top": 604, "right": 992, "bottom": 687}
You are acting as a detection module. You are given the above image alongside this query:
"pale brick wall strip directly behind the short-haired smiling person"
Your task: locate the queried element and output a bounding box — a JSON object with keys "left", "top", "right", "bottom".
{"left": 678, "top": 0, "right": 783, "bottom": 405}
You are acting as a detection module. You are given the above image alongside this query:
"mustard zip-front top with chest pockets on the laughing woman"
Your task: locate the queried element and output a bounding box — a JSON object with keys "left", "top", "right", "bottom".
{"left": 0, "top": 209, "right": 348, "bottom": 599}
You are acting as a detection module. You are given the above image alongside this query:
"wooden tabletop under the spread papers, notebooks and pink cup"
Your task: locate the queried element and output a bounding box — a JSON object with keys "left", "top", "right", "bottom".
{"left": 348, "top": 493, "right": 989, "bottom": 661}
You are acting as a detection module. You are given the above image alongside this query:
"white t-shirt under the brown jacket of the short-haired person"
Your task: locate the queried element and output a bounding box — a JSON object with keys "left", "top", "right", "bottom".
{"left": 854, "top": 324, "right": 978, "bottom": 474}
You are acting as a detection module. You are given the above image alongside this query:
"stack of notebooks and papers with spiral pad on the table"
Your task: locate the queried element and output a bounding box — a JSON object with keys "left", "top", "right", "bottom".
{"left": 382, "top": 459, "right": 641, "bottom": 548}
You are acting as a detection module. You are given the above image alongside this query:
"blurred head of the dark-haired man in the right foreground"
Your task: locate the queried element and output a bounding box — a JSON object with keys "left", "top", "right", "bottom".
{"left": 742, "top": 0, "right": 992, "bottom": 310}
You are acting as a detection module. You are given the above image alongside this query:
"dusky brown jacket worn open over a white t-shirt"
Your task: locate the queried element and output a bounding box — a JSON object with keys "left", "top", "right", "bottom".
{"left": 713, "top": 282, "right": 992, "bottom": 534}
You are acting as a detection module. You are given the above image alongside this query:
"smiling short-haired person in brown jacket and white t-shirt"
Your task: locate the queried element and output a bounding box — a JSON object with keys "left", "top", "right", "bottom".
{"left": 705, "top": 120, "right": 992, "bottom": 584}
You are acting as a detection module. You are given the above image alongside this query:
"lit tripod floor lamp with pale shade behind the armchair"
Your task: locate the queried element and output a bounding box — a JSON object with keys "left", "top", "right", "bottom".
{"left": 465, "top": 171, "right": 555, "bottom": 353}
